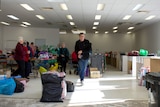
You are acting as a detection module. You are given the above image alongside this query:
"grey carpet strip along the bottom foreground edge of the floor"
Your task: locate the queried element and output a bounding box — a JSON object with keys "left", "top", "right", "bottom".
{"left": 0, "top": 98, "right": 148, "bottom": 107}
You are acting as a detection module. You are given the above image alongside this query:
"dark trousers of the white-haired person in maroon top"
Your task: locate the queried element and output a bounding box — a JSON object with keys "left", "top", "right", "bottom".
{"left": 16, "top": 60, "right": 25, "bottom": 78}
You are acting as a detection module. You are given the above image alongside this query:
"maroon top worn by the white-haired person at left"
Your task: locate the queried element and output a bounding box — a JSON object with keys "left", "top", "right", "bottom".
{"left": 14, "top": 42, "right": 25, "bottom": 60}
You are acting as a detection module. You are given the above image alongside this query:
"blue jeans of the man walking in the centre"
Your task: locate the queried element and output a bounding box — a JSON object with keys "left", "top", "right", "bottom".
{"left": 78, "top": 59, "right": 88, "bottom": 81}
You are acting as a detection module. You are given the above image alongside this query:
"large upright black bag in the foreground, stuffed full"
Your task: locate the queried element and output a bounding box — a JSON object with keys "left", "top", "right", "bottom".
{"left": 40, "top": 73, "right": 63, "bottom": 102}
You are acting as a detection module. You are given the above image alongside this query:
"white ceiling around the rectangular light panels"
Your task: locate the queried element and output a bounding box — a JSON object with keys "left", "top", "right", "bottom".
{"left": 0, "top": 0, "right": 160, "bottom": 33}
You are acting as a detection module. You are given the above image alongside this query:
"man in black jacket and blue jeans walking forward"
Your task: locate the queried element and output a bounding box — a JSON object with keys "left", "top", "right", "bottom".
{"left": 75, "top": 33, "right": 92, "bottom": 85}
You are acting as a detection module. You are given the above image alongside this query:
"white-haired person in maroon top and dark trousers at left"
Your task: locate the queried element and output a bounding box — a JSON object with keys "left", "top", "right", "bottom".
{"left": 14, "top": 37, "right": 25, "bottom": 78}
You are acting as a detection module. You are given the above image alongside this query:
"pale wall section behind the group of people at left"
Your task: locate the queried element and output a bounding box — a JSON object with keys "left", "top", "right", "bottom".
{"left": 0, "top": 26, "right": 59, "bottom": 50}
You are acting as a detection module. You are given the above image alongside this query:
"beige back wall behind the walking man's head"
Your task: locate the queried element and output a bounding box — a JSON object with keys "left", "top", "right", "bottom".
{"left": 60, "top": 34, "right": 135, "bottom": 52}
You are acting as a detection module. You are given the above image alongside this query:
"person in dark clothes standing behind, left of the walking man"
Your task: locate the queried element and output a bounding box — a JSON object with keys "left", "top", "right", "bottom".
{"left": 58, "top": 43, "right": 69, "bottom": 73}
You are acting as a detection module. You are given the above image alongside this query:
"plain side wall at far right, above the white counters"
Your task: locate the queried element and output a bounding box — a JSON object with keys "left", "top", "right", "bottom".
{"left": 135, "top": 22, "right": 160, "bottom": 53}
